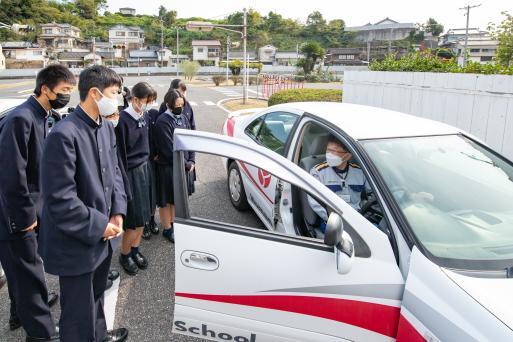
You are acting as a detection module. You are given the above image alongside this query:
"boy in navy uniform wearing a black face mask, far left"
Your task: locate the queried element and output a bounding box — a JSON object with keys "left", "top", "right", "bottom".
{"left": 0, "top": 65, "right": 76, "bottom": 341}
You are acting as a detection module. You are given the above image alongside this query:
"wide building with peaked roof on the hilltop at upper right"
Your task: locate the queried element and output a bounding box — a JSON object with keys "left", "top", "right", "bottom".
{"left": 345, "top": 18, "right": 416, "bottom": 42}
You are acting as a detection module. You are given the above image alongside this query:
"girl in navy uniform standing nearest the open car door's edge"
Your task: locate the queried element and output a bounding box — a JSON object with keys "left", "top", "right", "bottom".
{"left": 155, "top": 89, "right": 196, "bottom": 242}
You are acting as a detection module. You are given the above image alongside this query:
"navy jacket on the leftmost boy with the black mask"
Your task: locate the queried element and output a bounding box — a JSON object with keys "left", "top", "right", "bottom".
{"left": 0, "top": 96, "right": 48, "bottom": 240}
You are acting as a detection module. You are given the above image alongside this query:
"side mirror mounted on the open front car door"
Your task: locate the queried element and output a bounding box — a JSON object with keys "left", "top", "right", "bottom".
{"left": 324, "top": 213, "right": 354, "bottom": 274}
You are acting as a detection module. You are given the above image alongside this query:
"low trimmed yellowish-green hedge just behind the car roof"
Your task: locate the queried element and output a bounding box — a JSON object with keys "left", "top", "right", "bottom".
{"left": 269, "top": 88, "right": 342, "bottom": 106}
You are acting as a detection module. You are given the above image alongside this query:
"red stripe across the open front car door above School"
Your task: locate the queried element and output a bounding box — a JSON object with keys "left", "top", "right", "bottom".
{"left": 176, "top": 293, "right": 400, "bottom": 337}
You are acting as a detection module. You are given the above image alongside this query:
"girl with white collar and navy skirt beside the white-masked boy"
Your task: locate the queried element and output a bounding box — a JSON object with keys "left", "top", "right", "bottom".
{"left": 116, "top": 82, "right": 156, "bottom": 275}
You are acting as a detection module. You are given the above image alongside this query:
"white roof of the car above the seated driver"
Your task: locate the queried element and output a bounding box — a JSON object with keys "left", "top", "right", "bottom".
{"left": 272, "top": 102, "right": 462, "bottom": 140}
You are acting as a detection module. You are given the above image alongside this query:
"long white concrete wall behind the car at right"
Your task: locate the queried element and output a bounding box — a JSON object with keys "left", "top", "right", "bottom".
{"left": 343, "top": 71, "right": 513, "bottom": 160}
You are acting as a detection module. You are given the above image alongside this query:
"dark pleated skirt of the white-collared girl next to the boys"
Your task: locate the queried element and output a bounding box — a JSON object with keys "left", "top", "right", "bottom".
{"left": 123, "top": 162, "right": 153, "bottom": 229}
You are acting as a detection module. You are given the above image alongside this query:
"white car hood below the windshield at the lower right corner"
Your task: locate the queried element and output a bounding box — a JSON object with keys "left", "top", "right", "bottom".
{"left": 442, "top": 268, "right": 513, "bottom": 330}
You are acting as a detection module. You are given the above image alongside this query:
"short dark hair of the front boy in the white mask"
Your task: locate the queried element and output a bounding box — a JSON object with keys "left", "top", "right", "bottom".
{"left": 78, "top": 65, "right": 123, "bottom": 101}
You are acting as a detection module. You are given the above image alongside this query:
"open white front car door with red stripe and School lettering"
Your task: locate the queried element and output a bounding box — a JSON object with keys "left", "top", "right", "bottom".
{"left": 173, "top": 130, "right": 404, "bottom": 342}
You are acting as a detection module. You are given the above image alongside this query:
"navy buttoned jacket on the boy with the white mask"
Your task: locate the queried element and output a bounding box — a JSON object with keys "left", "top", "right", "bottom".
{"left": 39, "top": 106, "right": 126, "bottom": 276}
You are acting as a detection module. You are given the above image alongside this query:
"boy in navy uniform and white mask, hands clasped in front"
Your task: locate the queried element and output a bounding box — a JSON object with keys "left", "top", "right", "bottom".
{"left": 39, "top": 65, "right": 128, "bottom": 342}
